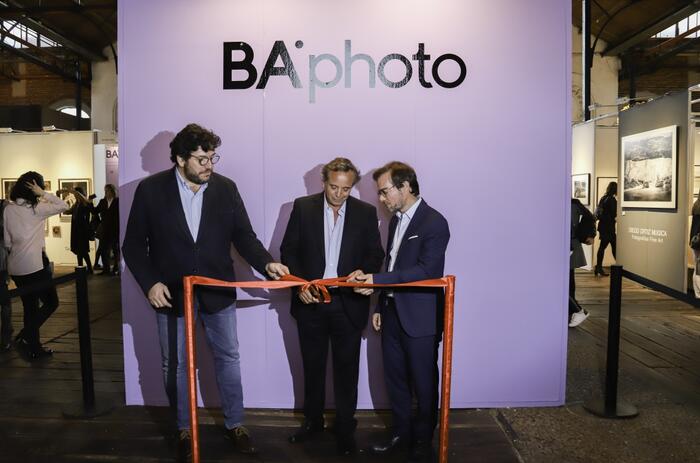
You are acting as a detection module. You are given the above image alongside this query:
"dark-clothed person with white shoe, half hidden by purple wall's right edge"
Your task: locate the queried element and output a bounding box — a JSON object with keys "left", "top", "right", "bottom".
{"left": 569, "top": 198, "right": 595, "bottom": 328}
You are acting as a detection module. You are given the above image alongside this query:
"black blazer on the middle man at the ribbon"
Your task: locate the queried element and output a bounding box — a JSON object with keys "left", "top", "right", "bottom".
{"left": 280, "top": 193, "right": 384, "bottom": 329}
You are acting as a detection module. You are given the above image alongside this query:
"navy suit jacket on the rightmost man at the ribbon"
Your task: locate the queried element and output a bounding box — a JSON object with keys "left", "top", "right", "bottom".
{"left": 373, "top": 200, "right": 450, "bottom": 337}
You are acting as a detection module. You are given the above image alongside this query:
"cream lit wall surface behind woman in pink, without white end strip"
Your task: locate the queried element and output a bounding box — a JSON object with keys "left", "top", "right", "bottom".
{"left": 0, "top": 131, "right": 95, "bottom": 265}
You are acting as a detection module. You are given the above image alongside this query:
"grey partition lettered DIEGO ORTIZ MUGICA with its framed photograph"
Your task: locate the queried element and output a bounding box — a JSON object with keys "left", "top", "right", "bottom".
{"left": 617, "top": 88, "right": 700, "bottom": 293}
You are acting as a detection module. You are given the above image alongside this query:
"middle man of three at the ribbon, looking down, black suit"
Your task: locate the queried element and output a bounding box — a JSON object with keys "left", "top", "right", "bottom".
{"left": 281, "top": 158, "right": 384, "bottom": 454}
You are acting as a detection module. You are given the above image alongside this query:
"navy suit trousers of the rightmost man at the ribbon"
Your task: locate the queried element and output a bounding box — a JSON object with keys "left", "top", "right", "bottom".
{"left": 382, "top": 298, "right": 440, "bottom": 442}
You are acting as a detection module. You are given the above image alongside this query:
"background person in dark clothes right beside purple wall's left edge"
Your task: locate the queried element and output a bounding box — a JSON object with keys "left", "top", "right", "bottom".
{"left": 95, "top": 183, "right": 119, "bottom": 275}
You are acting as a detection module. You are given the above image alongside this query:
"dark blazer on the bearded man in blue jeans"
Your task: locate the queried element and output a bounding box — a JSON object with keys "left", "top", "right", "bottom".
{"left": 122, "top": 168, "right": 273, "bottom": 314}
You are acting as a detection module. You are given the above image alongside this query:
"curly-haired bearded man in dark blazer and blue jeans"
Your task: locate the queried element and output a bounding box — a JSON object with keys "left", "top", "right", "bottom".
{"left": 122, "top": 124, "right": 289, "bottom": 461}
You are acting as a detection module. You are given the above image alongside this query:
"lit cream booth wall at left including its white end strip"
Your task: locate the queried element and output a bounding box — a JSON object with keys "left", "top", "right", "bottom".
{"left": 0, "top": 131, "right": 105, "bottom": 266}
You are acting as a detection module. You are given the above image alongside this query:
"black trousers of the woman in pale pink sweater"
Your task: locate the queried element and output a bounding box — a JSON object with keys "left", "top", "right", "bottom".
{"left": 12, "top": 258, "right": 58, "bottom": 349}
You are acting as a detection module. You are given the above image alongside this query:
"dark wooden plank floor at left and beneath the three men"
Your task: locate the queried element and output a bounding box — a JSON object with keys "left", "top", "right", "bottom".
{"left": 0, "top": 269, "right": 519, "bottom": 463}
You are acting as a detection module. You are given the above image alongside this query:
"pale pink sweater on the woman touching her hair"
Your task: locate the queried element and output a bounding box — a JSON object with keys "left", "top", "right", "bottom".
{"left": 3, "top": 192, "right": 68, "bottom": 275}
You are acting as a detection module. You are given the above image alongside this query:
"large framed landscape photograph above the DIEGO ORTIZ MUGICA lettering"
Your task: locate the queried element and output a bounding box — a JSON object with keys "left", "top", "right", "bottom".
{"left": 619, "top": 125, "right": 678, "bottom": 209}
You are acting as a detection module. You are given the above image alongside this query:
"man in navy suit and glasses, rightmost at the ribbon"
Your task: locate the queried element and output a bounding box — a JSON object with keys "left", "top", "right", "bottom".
{"left": 353, "top": 162, "right": 450, "bottom": 461}
